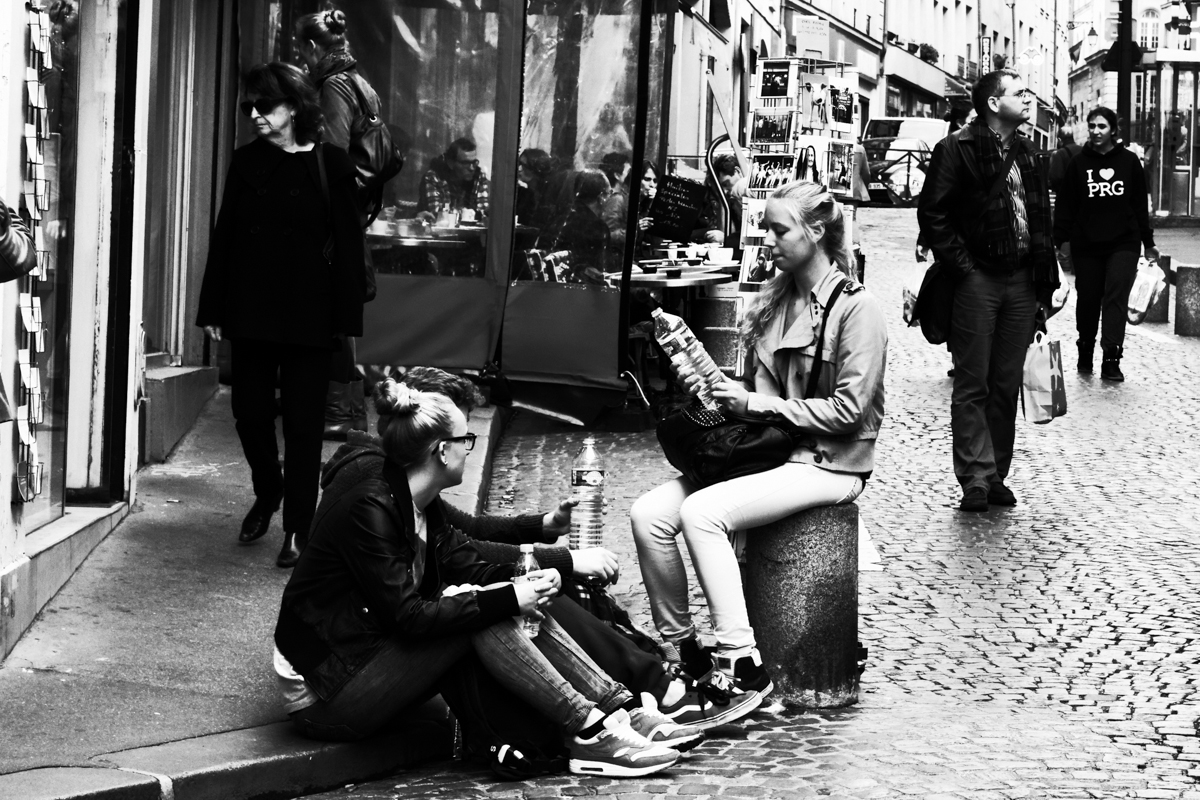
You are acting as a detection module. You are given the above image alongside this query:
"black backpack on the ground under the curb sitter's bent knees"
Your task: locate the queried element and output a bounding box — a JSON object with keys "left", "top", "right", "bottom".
{"left": 437, "top": 655, "right": 568, "bottom": 781}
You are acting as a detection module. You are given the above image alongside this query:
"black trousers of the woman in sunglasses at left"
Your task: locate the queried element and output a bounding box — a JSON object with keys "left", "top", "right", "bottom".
{"left": 230, "top": 339, "right": 329, "bottom": 534}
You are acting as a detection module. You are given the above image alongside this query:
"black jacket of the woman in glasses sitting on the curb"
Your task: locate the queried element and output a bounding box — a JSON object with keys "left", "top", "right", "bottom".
{"left": 275, "top": 443, "right": 520, "bottom": 700}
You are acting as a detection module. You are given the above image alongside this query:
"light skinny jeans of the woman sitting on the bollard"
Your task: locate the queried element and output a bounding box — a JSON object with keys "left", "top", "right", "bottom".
{"left": 630, "top": 462, "right": 863, "bottom": 658}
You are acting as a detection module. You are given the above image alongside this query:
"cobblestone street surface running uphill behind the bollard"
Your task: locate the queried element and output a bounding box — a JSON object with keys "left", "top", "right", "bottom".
{"left": 302, "top": 209, "right": 1200, "bottom": 799}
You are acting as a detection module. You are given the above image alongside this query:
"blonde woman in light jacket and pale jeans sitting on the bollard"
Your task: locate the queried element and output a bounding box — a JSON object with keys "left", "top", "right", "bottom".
{"left": 630, "top": 181, "right": 888, "bottom": 696}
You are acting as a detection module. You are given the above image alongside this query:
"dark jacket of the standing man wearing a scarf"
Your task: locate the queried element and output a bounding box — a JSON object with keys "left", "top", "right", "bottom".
{"left": 917, "top": 125, "right": 1058, "bottom": 300}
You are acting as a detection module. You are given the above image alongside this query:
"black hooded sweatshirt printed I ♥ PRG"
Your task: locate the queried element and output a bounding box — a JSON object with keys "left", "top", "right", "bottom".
{"left": 1054, "top": 143, "right": 1154, "bottom": 253}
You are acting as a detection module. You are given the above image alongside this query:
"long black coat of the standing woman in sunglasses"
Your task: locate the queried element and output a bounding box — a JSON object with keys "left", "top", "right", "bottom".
{"left": 196, "top": 139, "right": 366, "bottom": 347}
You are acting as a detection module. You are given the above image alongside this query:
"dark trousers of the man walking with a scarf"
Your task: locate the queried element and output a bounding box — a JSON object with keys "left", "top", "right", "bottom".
{"left": 950, "top": 269, "right": 1037, "bottom": 489}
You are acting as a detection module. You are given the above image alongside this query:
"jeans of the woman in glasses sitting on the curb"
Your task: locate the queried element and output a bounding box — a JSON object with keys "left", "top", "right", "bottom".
{"left": 292, "top": 615, "right": 632, "bottom": 741}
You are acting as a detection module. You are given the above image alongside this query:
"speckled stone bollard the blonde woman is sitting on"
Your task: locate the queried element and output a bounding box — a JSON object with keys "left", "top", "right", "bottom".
{"left": 745, "top": 503, "right": 859, "bottom": 708}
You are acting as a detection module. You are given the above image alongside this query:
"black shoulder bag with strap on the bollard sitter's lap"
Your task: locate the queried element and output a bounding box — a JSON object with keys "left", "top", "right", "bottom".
{"left": 655, "top": 278, "right": 848, "bottom": 487}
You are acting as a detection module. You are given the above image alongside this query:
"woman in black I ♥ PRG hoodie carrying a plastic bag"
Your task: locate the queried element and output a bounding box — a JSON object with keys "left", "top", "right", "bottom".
{"left": 1054, "top": 106, "right": 1158, "bottom": 380}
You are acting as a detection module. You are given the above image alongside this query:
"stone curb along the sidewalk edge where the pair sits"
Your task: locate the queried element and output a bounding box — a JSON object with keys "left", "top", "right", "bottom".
{"left": 0, "top": 407, "right": 508, "bottom": 800}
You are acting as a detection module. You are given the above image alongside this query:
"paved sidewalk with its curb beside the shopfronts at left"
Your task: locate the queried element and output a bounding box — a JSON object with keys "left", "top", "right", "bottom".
{"left": 0, "top": 389, "right": 499, "bottom": 800}
